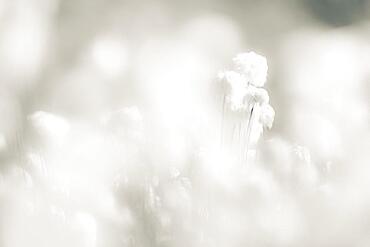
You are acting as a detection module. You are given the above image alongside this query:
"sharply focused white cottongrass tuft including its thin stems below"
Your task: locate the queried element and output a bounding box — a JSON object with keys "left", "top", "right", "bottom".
{"left": 219, "top": 52, "right": 275, "bottom": 163}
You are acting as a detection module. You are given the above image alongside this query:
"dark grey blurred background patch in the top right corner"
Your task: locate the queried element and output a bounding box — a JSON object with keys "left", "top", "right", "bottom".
{"left": 303, "top": 0, "right": 369, "bottom": 26}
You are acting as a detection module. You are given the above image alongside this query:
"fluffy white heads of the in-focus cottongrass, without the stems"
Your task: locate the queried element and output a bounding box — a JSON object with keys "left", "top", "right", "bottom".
{"left": 219, "top": 52, "right": 275, "bottom": 128}
